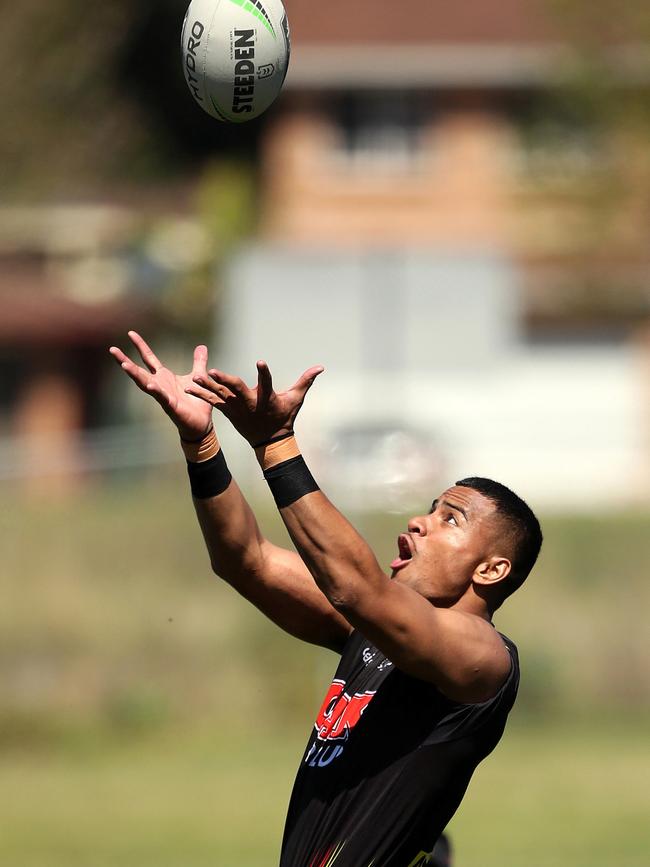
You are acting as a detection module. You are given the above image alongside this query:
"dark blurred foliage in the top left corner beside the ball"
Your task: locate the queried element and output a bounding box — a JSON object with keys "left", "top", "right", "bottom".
{"left": 0, "top": 0, "right": 263, "bottom": 202}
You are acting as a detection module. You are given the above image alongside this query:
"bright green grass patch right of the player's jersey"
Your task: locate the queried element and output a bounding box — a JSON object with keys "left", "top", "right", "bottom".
{"left": 451, "top": 720, "right": 650, "bottom": 867}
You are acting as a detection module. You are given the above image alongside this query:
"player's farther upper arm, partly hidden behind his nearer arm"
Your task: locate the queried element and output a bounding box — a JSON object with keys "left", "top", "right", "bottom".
{"left": 216, "top": 539, "right": 352, "bottom": 652}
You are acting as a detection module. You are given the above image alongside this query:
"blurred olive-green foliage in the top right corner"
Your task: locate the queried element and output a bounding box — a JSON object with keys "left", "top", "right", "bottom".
{"left": 533, "top": 0, "right": 650, "bottom": 254}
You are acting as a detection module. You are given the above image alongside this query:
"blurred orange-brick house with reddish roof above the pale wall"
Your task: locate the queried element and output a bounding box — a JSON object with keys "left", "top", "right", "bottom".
{"left": 261, "top": 0, "right": 650, "bottom": 328}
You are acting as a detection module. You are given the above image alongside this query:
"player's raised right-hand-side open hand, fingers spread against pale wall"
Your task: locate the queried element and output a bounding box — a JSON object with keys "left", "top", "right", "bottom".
{"left": 185, "top": 361, "right": 324, "bottom": 446}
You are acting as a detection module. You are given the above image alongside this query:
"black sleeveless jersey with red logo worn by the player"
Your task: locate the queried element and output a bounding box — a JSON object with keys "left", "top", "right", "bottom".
{"left": 280, "top": 632, "right": 519, "bottom": 867}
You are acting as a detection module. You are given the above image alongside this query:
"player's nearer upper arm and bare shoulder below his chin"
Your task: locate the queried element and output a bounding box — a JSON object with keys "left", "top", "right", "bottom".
{"left": 336, "top": 578, "right": 511, "bottom": 702}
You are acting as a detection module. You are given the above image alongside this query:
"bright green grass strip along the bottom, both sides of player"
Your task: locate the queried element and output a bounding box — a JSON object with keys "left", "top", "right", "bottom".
{"left": 0, "top": 725, "right": 650, "bottom": 867}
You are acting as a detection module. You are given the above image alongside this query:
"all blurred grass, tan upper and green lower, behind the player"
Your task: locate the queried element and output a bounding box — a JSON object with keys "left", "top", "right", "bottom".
{"left": 0, "top": 474, "right": 650, "bottom": 867}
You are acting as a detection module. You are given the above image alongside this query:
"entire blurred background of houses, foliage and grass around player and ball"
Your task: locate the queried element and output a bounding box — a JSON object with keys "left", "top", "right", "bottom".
{"left": 0, "top": 0, "right": 650, "bottom": 867}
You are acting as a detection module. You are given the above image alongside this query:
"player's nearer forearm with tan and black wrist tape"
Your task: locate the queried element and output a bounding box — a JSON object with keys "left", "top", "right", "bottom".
{"left": 256, "top": 438, "right": 387, "bottom": 611}
